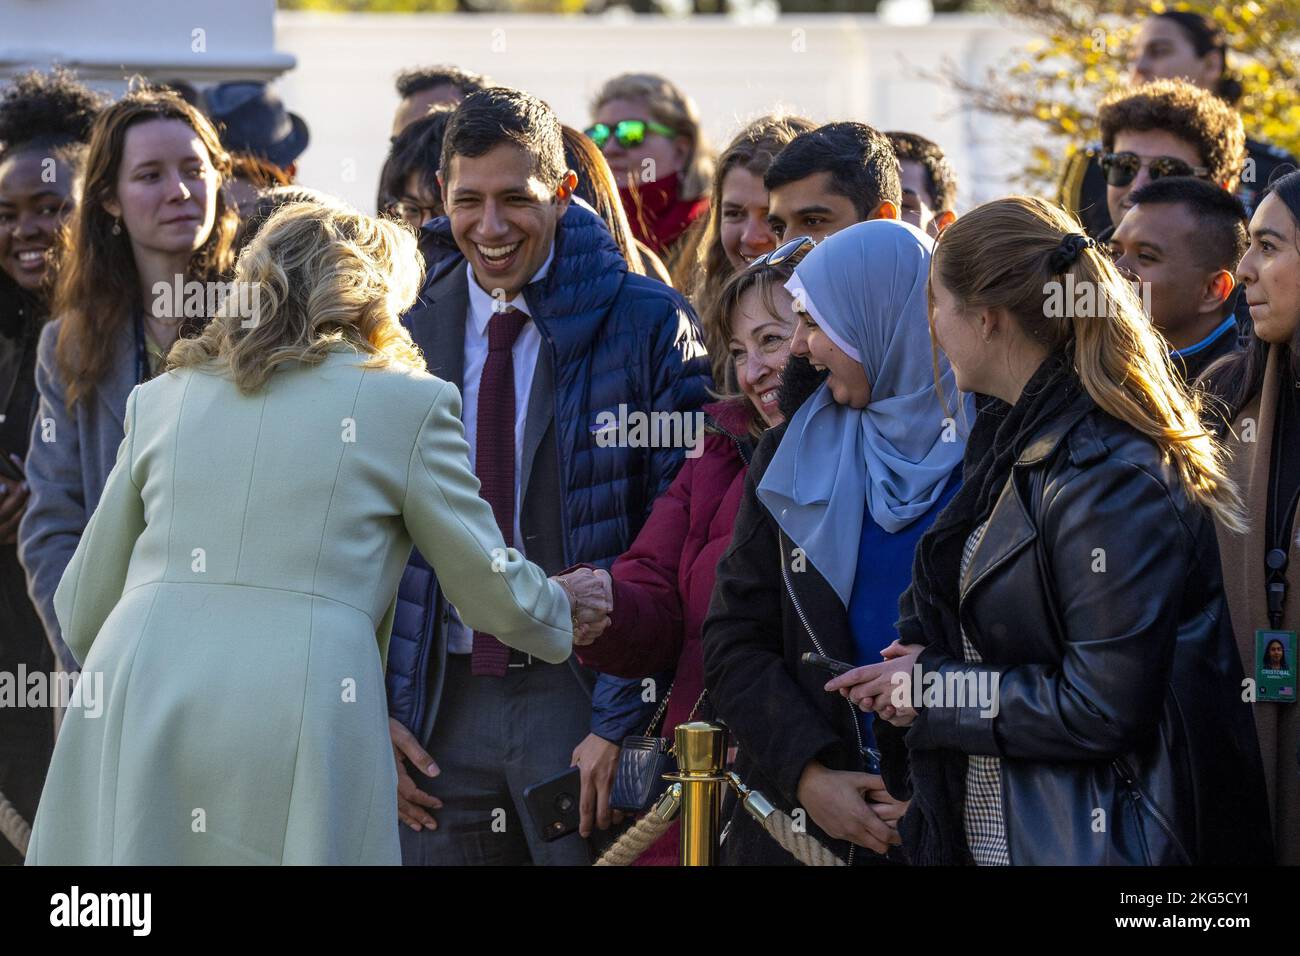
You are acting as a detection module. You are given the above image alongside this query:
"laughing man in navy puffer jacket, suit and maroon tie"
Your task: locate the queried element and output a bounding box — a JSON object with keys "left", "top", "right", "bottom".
{"left": 387, "top": 87, "right": 709, "bottom": 865}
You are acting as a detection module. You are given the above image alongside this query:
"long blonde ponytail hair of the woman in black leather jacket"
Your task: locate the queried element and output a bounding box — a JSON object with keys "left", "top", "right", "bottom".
{"left": 930, "top": 196, "right": 1245, "bottom": 531}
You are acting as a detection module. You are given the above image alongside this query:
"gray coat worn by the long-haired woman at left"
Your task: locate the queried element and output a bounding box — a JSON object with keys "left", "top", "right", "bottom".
{"left": 18, "top": 319, "right": 137, "bottom": 670}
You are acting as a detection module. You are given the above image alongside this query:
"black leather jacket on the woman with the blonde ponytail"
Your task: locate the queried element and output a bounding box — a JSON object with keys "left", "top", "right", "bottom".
{"left": 878, "top": 410, "right": 1273, "bottom": 865}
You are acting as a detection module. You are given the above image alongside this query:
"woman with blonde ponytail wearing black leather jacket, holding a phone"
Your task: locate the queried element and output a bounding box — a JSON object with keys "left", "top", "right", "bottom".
{"left": 827, "top": 196, "right": 1273, "bottom": 865}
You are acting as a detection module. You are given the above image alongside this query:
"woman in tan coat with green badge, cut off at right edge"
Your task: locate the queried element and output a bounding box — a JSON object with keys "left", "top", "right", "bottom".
{"left": 1201, "top": 173, "right": 1300, "bottom": 864}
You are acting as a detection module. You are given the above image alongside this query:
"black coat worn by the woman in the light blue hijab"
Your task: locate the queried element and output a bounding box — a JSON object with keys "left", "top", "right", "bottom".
{"left": 703, "top": 424, "right": 885, "bottom": 865}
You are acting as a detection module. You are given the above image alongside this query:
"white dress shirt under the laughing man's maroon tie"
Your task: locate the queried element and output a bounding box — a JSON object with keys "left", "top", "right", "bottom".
{"left": 447, "top": 245, "right": 555, "bottom": 654}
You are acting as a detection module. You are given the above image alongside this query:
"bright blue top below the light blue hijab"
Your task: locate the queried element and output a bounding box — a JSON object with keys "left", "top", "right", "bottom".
{"left": 849, "top": 467, "right": 961, "bottom": 773}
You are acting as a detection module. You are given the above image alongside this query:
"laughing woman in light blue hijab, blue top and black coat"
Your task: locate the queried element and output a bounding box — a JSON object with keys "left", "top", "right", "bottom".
{"left": 703, "top": 220, "right": 974, "bottom": 864}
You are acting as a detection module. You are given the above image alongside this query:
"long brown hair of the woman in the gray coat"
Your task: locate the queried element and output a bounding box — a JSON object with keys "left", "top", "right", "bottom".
{"left": 52, "top": 86, "right": 239, "bottom": 410}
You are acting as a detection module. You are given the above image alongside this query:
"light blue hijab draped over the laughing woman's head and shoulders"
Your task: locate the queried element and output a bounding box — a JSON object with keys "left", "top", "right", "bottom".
{"left": 758, "top": 220, "right": 972, "bottom": 607}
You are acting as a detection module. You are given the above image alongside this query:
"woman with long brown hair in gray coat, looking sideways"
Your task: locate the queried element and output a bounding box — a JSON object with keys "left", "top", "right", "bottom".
{"left": 18, "top": 88, "right": 238, "bottom": 669}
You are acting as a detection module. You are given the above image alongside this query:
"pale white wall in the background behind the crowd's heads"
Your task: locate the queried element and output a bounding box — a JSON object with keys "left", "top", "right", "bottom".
{"left": 0, "top": 0, "right": 1027, "bottom": 211}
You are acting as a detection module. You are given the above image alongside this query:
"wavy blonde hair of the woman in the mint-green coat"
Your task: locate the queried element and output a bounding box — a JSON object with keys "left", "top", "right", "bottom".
{"left": 166, "top": 202, "right": 425, "bottom": 394}
